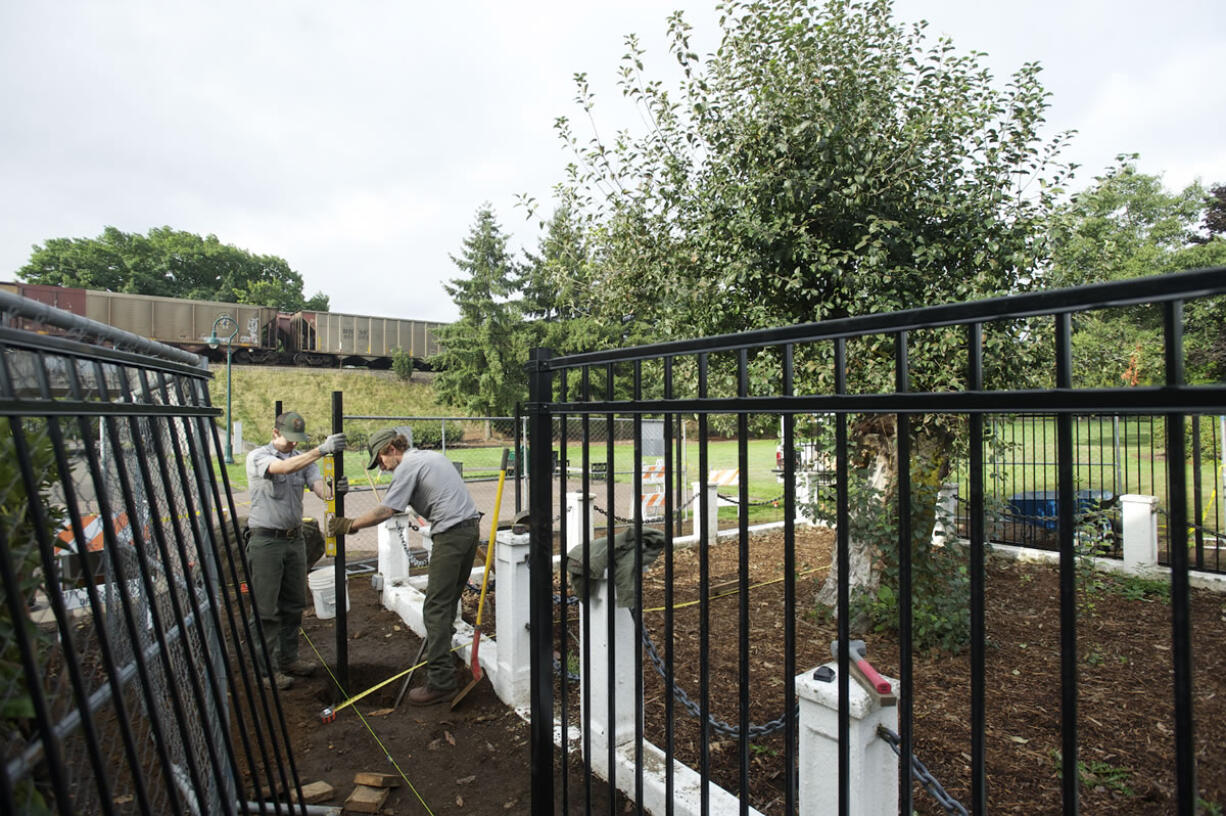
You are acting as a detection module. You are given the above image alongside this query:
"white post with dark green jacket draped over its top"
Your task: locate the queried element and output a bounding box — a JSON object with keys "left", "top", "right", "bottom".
{"left": 579, "top": 563, "right": 638, "bottom": 779}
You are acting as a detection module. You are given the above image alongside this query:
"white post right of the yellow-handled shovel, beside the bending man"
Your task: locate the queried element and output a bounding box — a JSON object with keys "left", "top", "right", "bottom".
{"left": 487, "top": 529, "right": 532, "bottom": 708}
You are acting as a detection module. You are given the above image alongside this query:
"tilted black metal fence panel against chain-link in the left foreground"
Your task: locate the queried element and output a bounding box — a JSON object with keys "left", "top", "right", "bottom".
{"left": 0, "top": 293, "right": 298, "bottom": 816}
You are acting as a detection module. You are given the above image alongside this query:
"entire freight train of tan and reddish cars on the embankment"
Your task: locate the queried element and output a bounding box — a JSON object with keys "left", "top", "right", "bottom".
{"left": 0, "top": 283, "right": 446, "bottom": 368}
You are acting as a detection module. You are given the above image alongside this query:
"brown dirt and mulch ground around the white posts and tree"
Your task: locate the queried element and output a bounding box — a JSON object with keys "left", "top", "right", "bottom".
{"left": 270, "top": 529, "right": 1226, "bottom": 815}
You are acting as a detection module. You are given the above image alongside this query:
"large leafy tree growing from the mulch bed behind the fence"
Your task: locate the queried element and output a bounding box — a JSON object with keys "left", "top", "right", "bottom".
{"left": 546, "top": 0, "right": 1069, "bottom": 637}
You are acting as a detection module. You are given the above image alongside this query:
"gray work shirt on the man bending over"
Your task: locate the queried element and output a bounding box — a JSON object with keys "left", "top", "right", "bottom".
{"left": 383, "top": 447, "right": 481, "bottom": 533}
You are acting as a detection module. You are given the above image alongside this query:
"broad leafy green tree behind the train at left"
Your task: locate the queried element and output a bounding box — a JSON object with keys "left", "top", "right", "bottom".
{"left": 17, "top": 227, "right": 327, "bottom": 311}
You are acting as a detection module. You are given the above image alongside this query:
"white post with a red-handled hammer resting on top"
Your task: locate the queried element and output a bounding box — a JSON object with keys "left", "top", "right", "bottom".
{"left": 796, "top": 663, "right": 899, "bottom": 816}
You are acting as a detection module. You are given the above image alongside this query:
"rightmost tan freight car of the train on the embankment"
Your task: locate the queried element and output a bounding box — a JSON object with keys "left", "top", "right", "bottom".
{"left": 289, "top": 311, "right": 444, "bottom": 368}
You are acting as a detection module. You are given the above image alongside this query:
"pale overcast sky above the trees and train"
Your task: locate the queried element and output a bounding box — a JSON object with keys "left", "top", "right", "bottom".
{"left": 0, "top": 0, "right": 1226, "bottom": 320}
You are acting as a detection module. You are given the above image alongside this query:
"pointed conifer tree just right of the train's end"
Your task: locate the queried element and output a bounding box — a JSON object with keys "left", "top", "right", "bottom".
{"left": 433, "top": 205, "right": 528, "bottom": 417}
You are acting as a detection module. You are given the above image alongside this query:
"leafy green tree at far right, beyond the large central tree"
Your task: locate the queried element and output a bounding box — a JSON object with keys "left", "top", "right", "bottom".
{"left": 1047, "top": 160, "right": 1226, "bottom": 386}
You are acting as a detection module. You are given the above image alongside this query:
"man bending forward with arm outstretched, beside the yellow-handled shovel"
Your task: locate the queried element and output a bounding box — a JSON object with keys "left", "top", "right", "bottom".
{"left": 329, "top": 428, "right": 481, "bottom": 706}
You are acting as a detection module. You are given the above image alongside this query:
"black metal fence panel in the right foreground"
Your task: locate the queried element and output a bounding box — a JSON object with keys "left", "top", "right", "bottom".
{"left": 526, "top": 268, "right": 1226, "bottom": 815}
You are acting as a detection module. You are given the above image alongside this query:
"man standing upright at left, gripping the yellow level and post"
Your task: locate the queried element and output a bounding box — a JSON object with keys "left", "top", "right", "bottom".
{"left": 246, "top": 410, "right": 345, "bottom": 689}
